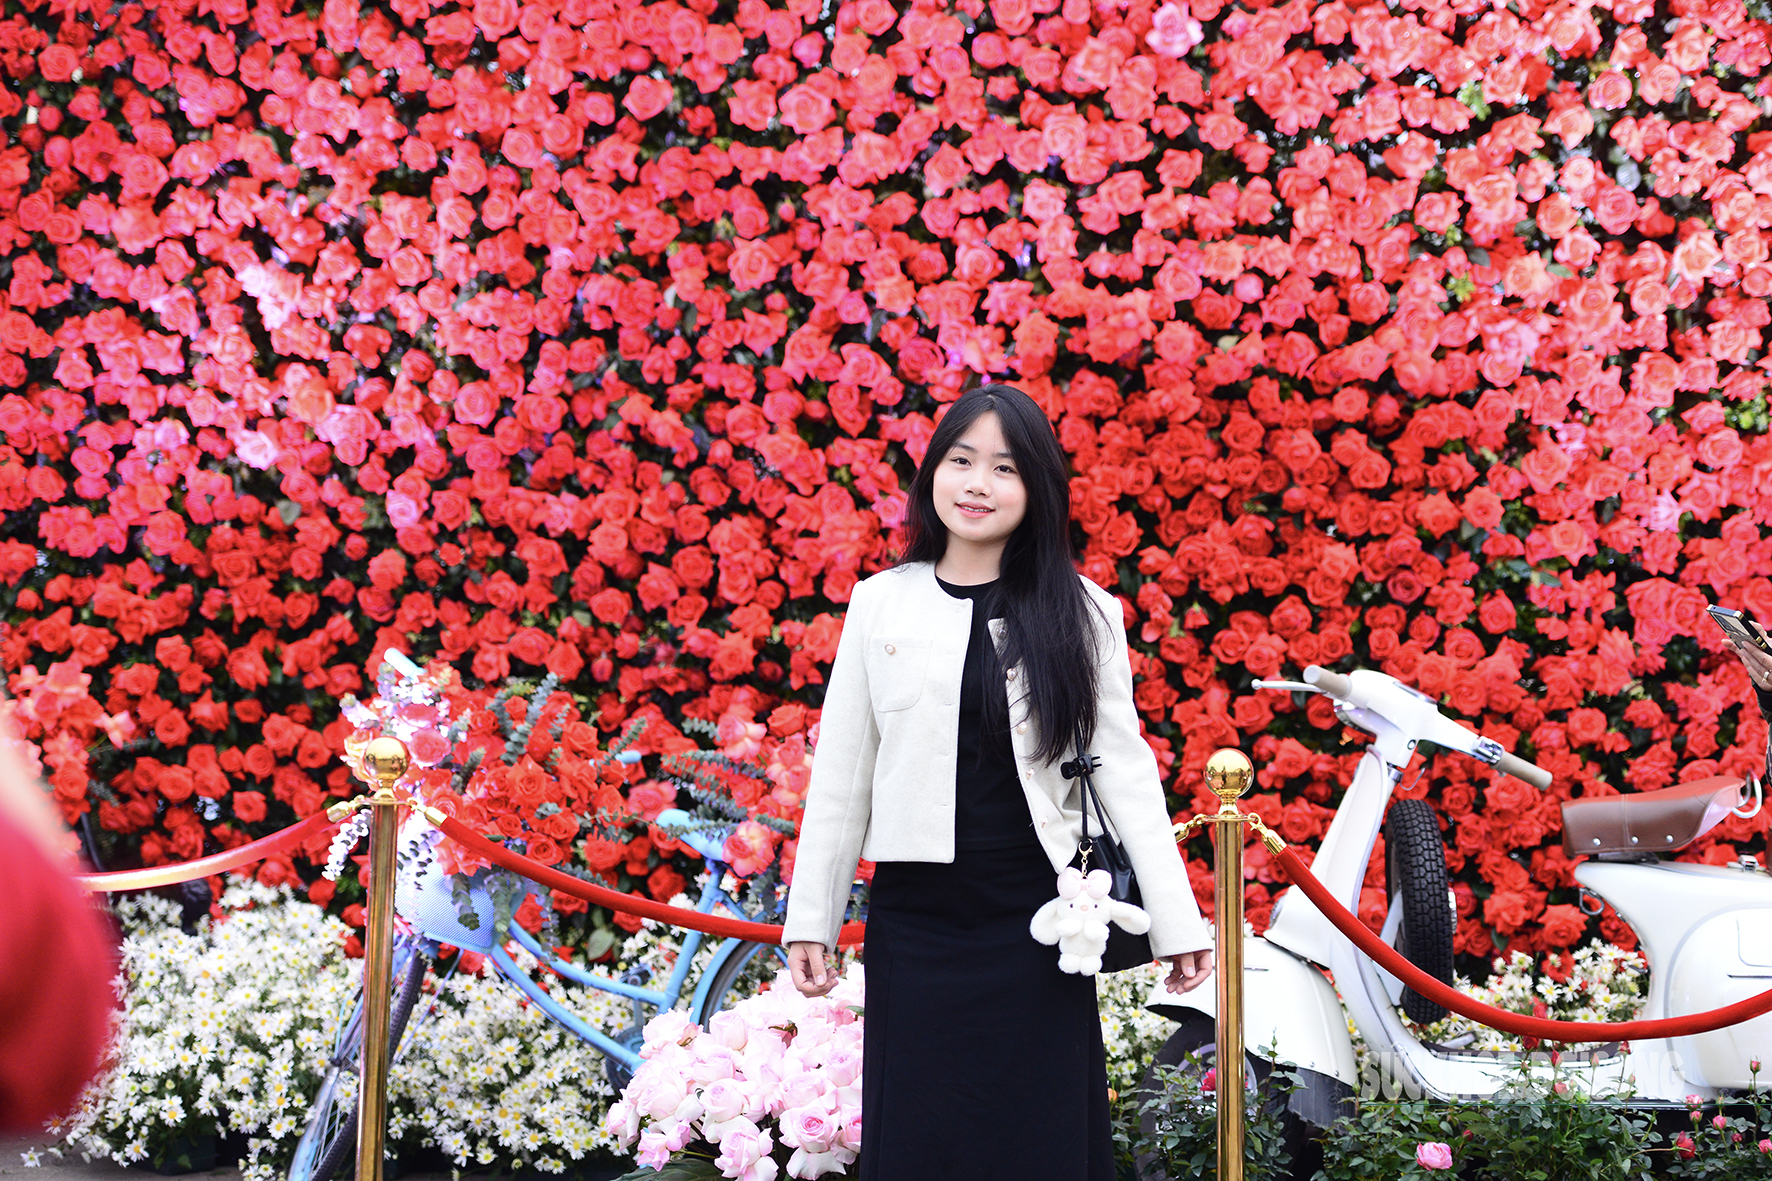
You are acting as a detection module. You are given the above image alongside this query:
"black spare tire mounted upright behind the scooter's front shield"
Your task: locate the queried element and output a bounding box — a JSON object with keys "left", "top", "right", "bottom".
{"left": 1384, "top": 800, "right": 1458, "bottom": 1025}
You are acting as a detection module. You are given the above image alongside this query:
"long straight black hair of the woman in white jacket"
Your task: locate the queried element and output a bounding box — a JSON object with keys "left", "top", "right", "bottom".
{"left": 900, "top": 385, "right": 1100, "bottom": 763}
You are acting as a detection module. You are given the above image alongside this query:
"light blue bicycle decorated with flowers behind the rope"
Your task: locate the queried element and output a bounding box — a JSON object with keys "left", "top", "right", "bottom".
{"left": 289, "top": 809, "right": 785, "bottom": 1181}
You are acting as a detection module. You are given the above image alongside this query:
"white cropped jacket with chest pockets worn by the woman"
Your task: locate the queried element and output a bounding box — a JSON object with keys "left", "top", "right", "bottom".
{"left": 783, "top": 562, "right": 1212, "bottom": 956}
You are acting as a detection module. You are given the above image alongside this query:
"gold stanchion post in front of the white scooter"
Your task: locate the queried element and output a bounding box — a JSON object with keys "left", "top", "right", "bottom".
{"left": 1203, "top": 748, "right": 1255, "bottom": 1181}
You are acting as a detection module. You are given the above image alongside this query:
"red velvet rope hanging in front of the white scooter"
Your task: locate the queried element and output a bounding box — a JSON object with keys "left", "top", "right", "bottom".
{"left": 1278, "top": 836, "right": 1772, "bottom": 1041}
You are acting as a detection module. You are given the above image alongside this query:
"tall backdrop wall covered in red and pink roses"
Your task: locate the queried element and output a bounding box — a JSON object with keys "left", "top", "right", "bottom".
{"left": 0, "top": 0, "right": 1772, "bottom": 954}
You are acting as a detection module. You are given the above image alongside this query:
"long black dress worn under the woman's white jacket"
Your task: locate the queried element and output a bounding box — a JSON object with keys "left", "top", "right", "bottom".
{"left": 859, "top": 582, "right": 1115, "bottom": 1181}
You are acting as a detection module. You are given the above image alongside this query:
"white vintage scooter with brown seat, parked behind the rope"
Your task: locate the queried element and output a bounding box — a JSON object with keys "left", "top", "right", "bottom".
{"left": 1146, "top": 665, "right": 1772, "bottom": 1126}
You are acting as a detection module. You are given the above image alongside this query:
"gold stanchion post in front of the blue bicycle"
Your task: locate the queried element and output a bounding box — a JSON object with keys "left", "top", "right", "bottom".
{"left": 356, "top": 738, "right": 409, "bottom": 1181}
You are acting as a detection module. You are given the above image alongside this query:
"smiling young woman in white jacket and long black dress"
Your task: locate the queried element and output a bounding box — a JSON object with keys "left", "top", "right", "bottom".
{"left": 785, "top": 385, "right": 1212, "bottom": 1181}
